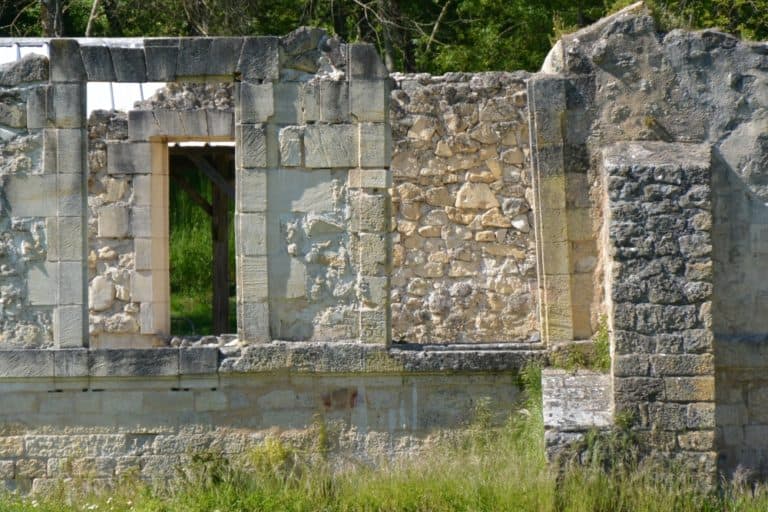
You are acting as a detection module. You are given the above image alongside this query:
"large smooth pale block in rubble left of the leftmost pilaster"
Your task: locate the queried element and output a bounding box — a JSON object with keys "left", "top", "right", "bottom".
{"left": 3, "top": 175, "right": 58, "bottom": 217}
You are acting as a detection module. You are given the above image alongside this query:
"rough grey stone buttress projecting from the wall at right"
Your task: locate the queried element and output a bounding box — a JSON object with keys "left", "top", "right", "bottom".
{"left": 603, "top": 142, "right": 717, "bottom": 477}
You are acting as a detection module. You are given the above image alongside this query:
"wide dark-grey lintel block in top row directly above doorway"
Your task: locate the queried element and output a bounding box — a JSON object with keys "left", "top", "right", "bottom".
{"left": 176, "top": 37, "right": 243, "bottom": 78}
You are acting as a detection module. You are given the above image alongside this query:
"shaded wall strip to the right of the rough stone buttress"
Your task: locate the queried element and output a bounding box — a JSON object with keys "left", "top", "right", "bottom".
{"left": 712, "top": 150, "right": 768, "bottom": 478}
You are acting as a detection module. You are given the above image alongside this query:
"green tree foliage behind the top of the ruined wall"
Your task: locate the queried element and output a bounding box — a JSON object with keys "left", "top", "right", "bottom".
{"left": 0, "top": 0, "right": 768, "bottom": 73}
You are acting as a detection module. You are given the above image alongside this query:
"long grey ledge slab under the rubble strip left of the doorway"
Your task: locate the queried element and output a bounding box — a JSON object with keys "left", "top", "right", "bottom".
{"left": 88, "top": 348, "right": 179, "bottom": 377}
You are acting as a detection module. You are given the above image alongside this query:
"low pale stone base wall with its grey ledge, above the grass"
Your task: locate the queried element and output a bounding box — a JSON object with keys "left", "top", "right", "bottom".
{"left": 0, "top": 343, "right": 540, "bottom": 492}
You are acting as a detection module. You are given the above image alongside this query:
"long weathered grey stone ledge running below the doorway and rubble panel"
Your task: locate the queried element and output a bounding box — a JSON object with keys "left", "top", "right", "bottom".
{"left": 0, "top": 342, "right": 547, "bottom": 379}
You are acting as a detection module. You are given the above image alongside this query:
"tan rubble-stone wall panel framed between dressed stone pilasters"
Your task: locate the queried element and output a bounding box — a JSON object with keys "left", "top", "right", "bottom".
{"left": 390, "top": 73, "right": 538, "bottom": 343}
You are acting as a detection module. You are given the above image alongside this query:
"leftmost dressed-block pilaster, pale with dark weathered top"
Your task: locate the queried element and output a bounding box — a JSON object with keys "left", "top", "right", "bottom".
{"left": 44, "top": 39, "right": 88, "bottom": 348}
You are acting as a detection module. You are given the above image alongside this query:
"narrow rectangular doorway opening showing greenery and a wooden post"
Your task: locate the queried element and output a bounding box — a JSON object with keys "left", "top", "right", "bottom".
{"left": 168, "top": 143, "right": 237, "bottom": 336}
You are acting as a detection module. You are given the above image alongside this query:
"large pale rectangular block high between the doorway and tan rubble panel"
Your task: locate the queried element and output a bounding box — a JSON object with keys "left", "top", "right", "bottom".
{"left": 304, "top": 124, "right": 356, "bottom": 169}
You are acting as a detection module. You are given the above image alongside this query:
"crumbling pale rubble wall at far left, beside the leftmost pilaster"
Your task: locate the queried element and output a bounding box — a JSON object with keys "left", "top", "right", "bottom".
{"left": 0, "top": 57, "right": 58, "bottom": 348}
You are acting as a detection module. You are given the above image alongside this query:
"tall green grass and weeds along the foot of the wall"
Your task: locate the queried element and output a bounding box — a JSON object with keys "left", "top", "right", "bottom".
{"left": 0, "top": 370, "right": 768, "bottom": 512}
